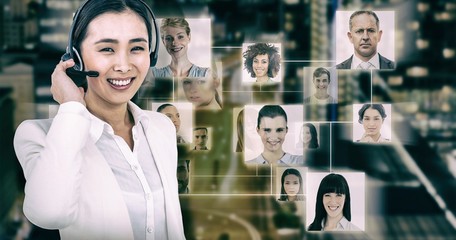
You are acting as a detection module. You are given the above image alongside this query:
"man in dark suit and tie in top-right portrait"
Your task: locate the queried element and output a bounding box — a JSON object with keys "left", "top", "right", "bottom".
{"left": 336, "top": 11, "right": 396, "bottom": 69}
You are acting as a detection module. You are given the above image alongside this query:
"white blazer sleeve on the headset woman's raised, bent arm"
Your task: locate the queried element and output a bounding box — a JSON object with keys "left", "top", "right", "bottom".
{"left": 14, "top": 102, "right": 90, "bottom": 229}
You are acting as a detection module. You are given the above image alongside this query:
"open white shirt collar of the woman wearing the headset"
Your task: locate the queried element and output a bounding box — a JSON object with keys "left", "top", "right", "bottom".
{"left": 89, "top": 102, "right": 149, "bottom": 142}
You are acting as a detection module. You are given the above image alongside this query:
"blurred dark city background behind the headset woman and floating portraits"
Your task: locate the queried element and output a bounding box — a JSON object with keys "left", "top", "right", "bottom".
{"left": 0, "top": 0, "right": 456, "bottom": 239}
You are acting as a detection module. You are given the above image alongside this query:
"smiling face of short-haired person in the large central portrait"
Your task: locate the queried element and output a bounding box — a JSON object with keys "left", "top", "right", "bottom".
{"left": 257, "top": 116, "right": 288, "bottom": 152}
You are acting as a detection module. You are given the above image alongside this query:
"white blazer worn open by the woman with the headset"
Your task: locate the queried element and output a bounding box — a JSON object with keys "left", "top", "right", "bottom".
{"left": 14, "top": 102, "right": 185, "bottom": 240}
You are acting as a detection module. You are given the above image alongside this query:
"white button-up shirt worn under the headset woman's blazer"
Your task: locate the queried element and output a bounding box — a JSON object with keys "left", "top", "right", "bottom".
{"left": 86, "top": 105, "right": 168, "bottom": 239}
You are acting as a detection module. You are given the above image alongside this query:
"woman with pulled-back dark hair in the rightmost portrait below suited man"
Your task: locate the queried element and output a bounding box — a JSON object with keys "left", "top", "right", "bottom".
{"left": 357, "top": 103, "right": 391, "bottom": 143}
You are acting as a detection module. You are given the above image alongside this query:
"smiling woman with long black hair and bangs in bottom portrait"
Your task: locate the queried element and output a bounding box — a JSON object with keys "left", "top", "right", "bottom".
{"left": 308, "top": 173, "right": 361, "bottom": 231}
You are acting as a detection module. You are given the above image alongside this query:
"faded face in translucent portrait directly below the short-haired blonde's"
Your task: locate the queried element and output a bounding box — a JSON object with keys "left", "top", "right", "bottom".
{"left": 182, "top": 77, "right": 215, "bottom": 107}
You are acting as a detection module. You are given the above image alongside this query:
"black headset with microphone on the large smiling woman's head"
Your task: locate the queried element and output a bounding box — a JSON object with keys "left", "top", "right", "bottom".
{"left": 61, "top": 0, "right": 160, "bottom": 89}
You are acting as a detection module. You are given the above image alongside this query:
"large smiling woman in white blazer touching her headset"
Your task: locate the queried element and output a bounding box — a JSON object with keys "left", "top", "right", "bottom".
{"left": 14, "top": 0, "right": 185, "bottom": 239}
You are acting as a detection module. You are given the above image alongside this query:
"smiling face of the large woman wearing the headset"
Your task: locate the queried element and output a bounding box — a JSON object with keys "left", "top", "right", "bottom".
{"left": 81, "top": 11, "right": 150, "bottom": 104}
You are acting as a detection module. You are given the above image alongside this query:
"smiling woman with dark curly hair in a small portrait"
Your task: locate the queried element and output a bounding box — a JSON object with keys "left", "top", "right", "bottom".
{"left": 243, "top": 43, "right": 280, "bottom": 84}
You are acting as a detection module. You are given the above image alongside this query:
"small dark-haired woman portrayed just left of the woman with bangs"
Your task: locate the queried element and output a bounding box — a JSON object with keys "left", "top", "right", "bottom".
{"left": 278, "top": 168, "right": 304, "bottom": 201}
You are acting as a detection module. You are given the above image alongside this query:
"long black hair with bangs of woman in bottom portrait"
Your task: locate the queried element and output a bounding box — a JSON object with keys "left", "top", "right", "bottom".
{"left": 308, "top": 173, "right": 351, "bottom": 231}
